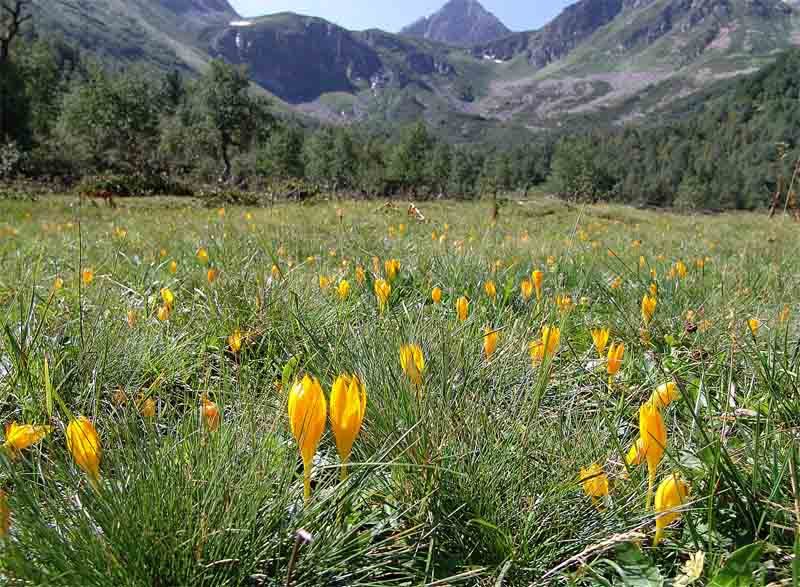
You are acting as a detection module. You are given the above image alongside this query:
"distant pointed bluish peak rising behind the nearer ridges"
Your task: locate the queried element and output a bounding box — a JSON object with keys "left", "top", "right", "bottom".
{"left": 400, "top": 0, "right": 511, "bottom": 47}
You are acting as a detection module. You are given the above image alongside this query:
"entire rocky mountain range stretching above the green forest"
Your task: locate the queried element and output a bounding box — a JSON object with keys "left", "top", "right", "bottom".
{"left": 20, "top": 0, "right": 800, "bottom": 142}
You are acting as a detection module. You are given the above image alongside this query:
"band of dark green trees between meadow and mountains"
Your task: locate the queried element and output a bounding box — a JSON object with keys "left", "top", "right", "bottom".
{"left": 0, "top": 28, "right": 800, "bottom": 210}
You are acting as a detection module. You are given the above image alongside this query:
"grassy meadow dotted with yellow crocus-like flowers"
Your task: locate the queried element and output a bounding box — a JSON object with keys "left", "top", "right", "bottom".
{"left": 0, "top": 198, "right": 800, "bottom": 587}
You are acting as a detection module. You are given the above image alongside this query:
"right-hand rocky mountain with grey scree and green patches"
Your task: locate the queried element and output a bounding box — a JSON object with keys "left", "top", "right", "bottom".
{"left": 473, "top": 0, "right": 800, "bottom": 128}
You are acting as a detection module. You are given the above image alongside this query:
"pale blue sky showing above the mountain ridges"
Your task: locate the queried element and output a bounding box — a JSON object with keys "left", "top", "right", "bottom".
{"left": 230, "top": 0, "right": 576, "bottom": 32}
